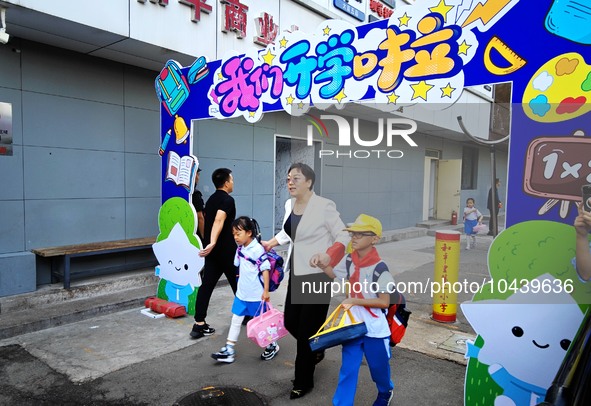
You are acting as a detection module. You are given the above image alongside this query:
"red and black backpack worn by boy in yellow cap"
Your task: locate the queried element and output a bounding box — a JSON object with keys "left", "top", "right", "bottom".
{"left": 345, "top": 255, "right": 412, "bottom": 347}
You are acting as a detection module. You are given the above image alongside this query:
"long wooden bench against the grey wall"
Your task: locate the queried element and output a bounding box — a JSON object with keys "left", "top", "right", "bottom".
{"left": 31, "top": 237, "right": 157, "bottom": 289}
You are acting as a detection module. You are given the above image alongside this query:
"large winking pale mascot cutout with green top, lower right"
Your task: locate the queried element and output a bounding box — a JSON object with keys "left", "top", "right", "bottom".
{"left": 461, "top": 221, "right": 591, "bottom": 406}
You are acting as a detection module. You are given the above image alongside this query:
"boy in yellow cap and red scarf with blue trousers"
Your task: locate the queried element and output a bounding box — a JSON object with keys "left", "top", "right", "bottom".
{"left": 317, "top": 214, "right": 394, "bottom": 406}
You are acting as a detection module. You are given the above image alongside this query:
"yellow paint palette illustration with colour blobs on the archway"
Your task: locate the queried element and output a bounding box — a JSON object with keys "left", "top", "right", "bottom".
{"left": 523, "top": 52, "right": 591, "bottom": 123}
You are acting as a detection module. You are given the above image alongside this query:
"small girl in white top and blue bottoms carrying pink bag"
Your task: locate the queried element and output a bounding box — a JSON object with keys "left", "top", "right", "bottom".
{"left": 211, "top": 216, "right": 279, "bottom": 363}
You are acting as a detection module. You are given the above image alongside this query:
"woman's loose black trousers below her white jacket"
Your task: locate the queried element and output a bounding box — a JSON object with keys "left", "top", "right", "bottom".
{"left": 284, "top": 274, "right": 330, "bottom": 389}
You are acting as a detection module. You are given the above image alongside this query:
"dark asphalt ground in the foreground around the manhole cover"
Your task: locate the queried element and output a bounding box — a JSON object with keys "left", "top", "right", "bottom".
{"left": 0, "top": 339, "right": 465, "bottom": 406}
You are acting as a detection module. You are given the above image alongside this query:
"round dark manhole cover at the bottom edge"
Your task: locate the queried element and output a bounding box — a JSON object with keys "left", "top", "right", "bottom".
{"left": 175, "top": 386, "right": 267, "bottom": 406}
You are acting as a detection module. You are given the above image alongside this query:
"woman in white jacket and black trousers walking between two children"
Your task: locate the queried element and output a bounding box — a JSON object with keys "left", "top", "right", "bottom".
{"left": 263, "top": 163, "right": 349, "bottom": 399}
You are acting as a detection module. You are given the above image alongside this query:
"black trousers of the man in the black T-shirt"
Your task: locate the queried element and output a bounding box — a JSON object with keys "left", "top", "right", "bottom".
{"left": 195, "top": 255, "right": 238, "bottom": 322}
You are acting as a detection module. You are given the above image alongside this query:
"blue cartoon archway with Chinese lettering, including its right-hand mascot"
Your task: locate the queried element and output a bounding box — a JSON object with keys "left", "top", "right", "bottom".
{"left": 155, "top": 0, "right": 591, "bottom": 405}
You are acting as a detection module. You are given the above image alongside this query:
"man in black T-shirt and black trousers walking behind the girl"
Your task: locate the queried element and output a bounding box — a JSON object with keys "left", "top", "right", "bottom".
{"left": 191, "top": 168, "right": 237, "bottom": 338}
